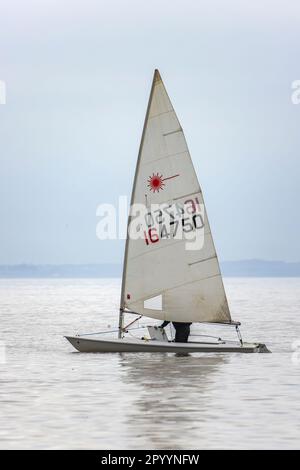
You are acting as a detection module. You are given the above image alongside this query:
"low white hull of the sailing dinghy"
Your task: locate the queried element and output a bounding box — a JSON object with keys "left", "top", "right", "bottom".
{"left": 65, "top": 336, "right": 270, "bottom": 354}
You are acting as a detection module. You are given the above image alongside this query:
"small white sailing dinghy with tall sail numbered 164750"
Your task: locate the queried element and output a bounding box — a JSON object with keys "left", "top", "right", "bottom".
{"left": 66, "top": 70, "right": 269, "bottom": 354}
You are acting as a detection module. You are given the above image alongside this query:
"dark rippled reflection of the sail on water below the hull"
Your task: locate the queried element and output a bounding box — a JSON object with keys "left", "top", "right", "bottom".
{"left": 120, "top": 354, "right": 228, "bottom": 448}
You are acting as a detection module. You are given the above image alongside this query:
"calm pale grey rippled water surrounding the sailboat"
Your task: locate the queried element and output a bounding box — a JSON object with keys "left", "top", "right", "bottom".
{"left": 0, "top": 278, "right": 300, "bottom": 449}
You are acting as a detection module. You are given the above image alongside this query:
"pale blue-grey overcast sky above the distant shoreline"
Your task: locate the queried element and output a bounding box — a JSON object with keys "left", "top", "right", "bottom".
{"left": 0, "top": 0, "right": 300, "bottom": 263}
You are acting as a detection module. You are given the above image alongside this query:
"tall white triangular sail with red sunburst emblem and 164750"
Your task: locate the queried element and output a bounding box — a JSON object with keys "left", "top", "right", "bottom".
{"left": 121, "top": 70, "right": 231, "bottom": 322}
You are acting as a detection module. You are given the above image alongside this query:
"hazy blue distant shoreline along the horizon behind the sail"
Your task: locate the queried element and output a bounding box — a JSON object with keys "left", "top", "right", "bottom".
{"left": 0, "top": 260, "right": 300, "bottom": 279}
